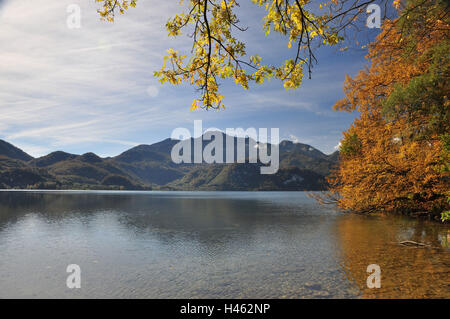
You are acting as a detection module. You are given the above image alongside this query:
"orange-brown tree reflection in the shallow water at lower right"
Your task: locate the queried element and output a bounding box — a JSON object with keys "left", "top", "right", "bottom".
{"left": 337, "top": 215, "right": 450, "bottom": 298}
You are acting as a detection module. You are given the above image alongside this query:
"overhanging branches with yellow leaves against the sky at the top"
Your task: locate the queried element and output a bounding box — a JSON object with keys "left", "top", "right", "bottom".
{"left": 95, "top": 0, "right": 398, "bottom": 110}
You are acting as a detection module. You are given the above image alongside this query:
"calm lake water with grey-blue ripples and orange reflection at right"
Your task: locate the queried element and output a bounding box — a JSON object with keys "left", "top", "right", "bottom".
{"left": 0, "top": 191, "right": 450, "bottom": 298}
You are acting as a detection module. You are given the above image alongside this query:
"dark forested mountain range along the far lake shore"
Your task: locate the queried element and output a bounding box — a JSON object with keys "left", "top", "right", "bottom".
{"left": 0, "top": 136, "right": 338, "bottom": 191}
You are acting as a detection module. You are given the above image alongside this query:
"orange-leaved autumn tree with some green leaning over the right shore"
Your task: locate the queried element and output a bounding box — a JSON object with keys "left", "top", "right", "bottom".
{"left": 330, "top": 0, "right": 450, "bottom": 218}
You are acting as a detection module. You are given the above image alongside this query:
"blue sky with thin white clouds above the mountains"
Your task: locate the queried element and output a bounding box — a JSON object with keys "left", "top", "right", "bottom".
{"left": 0, "top": 0, "right": 380, "bottom": 157}
